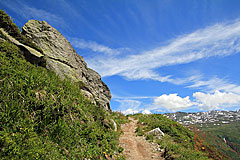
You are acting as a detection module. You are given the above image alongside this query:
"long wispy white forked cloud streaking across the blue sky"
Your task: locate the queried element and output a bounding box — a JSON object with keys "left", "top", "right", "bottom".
{"left": 86, "top": 20, "right": 240, "bottom": 91}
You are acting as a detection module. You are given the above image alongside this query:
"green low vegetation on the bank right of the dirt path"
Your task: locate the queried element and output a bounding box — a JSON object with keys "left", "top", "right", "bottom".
{"left": 133, "top": 114, "right": 228, "bottom": 160}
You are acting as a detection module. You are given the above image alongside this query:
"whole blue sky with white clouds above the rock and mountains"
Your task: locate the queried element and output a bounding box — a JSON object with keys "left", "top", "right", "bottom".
{"left": 0, "top": 0, "right": 240, "bottom": 114}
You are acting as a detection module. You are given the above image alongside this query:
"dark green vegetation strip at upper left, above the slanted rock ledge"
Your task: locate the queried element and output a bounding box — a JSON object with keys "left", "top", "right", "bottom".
{"left": 0, "top": 10, "right": 43, "bottom": 53}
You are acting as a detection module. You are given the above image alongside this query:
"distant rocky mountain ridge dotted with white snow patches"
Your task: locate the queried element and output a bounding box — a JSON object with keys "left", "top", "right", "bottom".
{"left": 164, "top": 109, "right": 240, "bottom": 125}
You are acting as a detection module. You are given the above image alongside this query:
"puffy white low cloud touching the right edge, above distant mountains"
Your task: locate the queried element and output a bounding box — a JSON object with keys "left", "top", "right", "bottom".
{"left": 193, "top": 91, "right": 240, "bottom": 110}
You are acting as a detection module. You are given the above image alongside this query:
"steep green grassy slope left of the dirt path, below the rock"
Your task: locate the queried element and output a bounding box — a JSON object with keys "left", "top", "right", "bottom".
{"left": 0, "top": 11, "right": 125, "bottom": 160}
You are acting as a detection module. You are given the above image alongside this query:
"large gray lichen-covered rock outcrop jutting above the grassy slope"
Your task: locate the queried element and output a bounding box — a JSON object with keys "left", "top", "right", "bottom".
{"left": 22, "top": 20, "right": 111, "bottom": 110}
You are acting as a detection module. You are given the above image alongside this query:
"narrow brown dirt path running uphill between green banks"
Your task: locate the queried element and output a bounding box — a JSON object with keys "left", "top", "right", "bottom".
{"left": 120, "top": 118, "right": 163, "bottom": 160}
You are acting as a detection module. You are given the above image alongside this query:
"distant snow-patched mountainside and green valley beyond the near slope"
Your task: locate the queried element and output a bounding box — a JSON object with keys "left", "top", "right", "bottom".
{"left": 165, "top": 110, "right": 240, "bottom": 159}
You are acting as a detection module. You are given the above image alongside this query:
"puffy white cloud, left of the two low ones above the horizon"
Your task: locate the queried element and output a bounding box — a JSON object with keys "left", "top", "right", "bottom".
{"left": 154, "top": 93, "right": 195, "bottom": 111}
